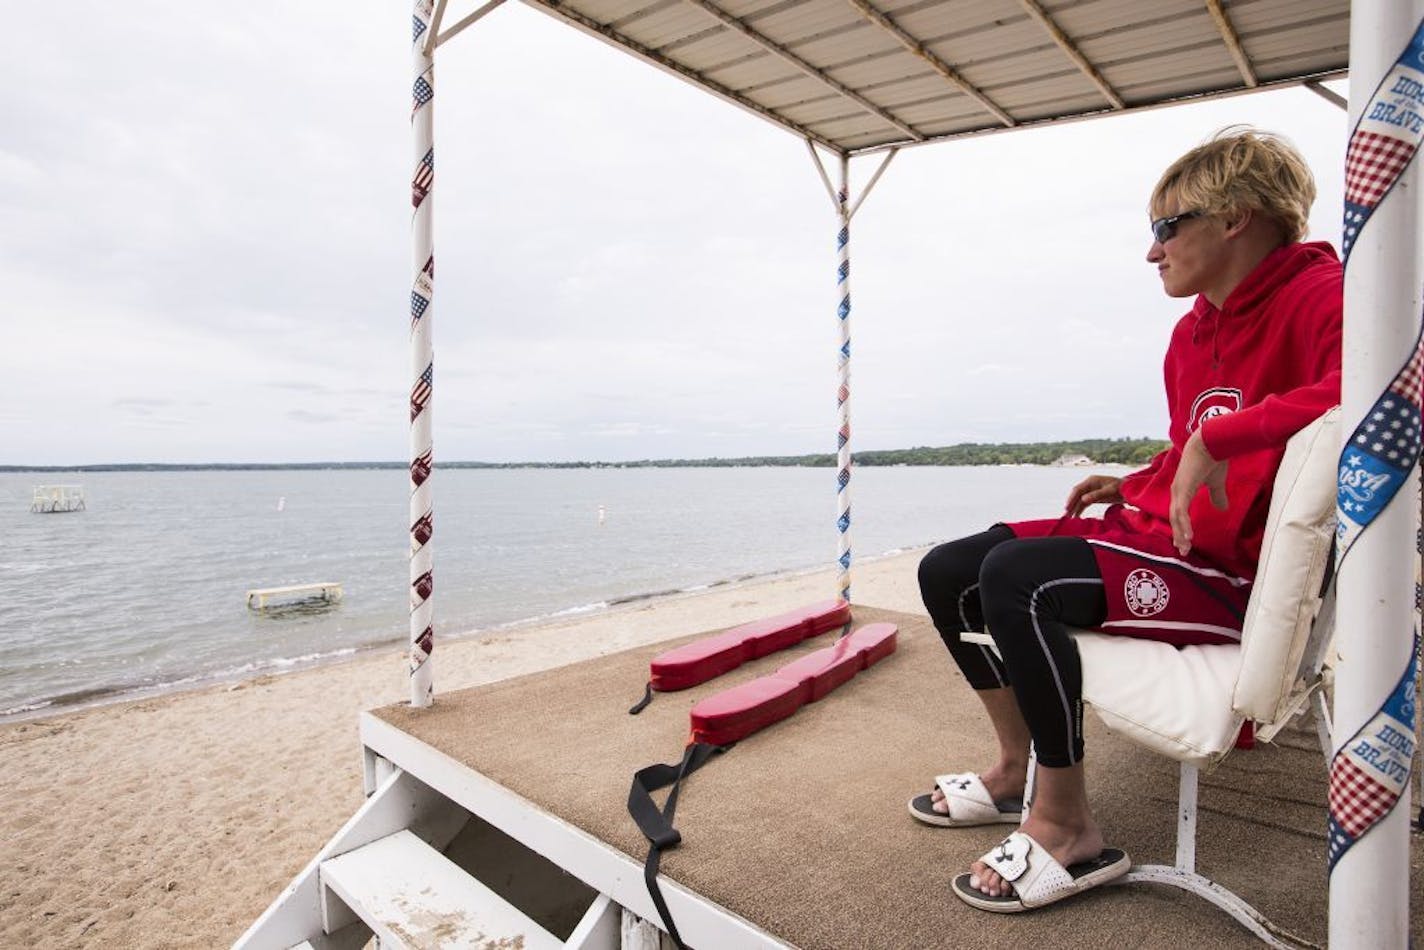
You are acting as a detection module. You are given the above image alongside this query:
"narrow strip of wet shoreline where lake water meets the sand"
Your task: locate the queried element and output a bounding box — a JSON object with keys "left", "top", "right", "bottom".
{"left": 0, "top": 543, "right": 933, "bottom": 728}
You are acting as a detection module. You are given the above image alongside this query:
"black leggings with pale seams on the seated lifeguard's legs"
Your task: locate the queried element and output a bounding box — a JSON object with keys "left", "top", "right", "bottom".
{"left": 920, "top": 524, "right": 1108, "bottom": 768}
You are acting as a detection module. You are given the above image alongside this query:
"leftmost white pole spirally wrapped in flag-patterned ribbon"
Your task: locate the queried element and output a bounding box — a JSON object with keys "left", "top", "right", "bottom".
{"left": 410, "top": 0, "right": 436, "bottom": 708}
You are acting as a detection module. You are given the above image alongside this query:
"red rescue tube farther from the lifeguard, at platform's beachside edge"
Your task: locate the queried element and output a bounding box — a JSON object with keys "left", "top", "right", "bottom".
{"left": 648, "top": 600, "right": 850, "bottom": 692}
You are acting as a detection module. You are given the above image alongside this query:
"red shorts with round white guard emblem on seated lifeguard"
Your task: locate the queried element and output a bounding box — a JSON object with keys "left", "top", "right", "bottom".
{"left": 1005, "top": 506, "right": 1252, "bottom": 647}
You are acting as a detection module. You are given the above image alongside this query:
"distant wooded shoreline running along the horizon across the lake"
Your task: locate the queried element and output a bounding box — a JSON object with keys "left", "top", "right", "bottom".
{"left": 0, "top": 439, "right": 1166, "bottom": 471}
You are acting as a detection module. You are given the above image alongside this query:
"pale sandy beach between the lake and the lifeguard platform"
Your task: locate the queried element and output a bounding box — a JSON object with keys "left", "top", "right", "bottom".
{"left": 0, "top": 553, "right": 923, "bottom": 947}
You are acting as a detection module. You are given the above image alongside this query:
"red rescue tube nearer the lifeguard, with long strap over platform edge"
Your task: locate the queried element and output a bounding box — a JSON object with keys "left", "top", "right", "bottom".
{"left": 692, "top": 624, "right": 897, "bottom": 745}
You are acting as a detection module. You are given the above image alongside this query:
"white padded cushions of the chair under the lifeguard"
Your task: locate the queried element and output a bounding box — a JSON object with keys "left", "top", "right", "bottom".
{"left": 1075, "top": 407, "right": 1340, "bottom": 766}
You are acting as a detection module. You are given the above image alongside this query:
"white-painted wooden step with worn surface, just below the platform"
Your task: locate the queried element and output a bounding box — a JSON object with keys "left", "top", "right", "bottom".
{"left": 320, "top": 830, "right": 564, "bottom": 950}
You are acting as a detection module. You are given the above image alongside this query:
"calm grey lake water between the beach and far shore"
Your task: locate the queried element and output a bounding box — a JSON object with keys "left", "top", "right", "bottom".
{"left": 0, "top": 466, "right": 1105, "bottom": 718}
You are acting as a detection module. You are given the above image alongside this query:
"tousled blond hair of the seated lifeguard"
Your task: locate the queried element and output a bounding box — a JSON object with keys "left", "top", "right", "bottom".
{"left": 1148, "top": 125, "right": 1316, "bottom": 241}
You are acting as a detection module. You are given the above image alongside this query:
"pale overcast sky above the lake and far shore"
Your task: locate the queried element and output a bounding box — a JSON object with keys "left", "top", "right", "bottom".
{"left": 0, "top": 0, "right": 1346, "bottom": 464}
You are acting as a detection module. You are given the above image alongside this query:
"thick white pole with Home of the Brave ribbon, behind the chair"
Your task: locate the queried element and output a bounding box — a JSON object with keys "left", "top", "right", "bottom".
{"left": 1329, "top": 7, "right": 1424, "bottom": 949}
